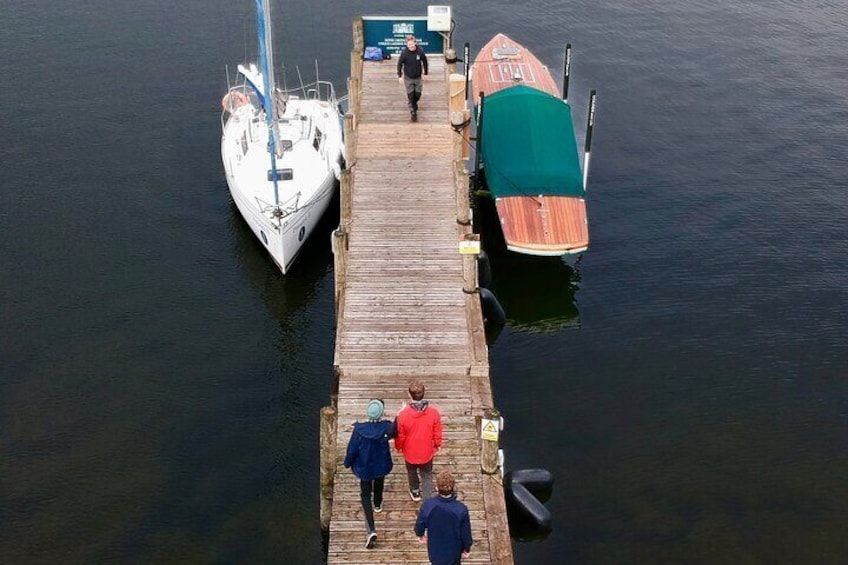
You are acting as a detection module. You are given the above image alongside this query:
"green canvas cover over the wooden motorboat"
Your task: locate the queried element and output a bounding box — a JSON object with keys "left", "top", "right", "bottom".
{"left": 480, "top": 85, "right": 585, "bottom": 197}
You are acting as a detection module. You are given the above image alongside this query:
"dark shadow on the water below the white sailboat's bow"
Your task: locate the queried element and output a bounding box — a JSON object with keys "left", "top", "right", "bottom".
{"left": 230, "top": 191, "right": 339, "bottom": 321}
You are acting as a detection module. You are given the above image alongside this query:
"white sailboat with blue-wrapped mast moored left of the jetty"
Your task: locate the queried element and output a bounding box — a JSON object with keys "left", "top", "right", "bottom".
{"left": 221, "top": 0, "right": 343, "bottom": 274}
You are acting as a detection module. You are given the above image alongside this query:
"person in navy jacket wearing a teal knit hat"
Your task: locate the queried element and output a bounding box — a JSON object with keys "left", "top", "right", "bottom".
{"left": 344, "top": 399, "right": 396, "bottom": 549}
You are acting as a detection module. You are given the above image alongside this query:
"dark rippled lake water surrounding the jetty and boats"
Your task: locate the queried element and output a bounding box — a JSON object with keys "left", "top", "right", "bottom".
{"left": 0, "top": 0, "right": 848, "bottom": 564}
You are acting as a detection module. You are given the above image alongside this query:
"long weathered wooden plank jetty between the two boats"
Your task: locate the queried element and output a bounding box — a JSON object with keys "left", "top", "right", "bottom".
{"left": 321, "top": 15, "right": 513, "bottom": 564}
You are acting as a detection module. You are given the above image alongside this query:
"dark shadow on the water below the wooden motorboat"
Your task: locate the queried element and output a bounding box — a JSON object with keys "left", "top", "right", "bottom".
{"left": 475, "top": 189, "right": 580, "bottom": 332}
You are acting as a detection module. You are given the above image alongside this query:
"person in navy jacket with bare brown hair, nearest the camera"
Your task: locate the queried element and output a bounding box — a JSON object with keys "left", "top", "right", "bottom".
{"left": 415, "top": 469, "right": 474, "bottom": 565}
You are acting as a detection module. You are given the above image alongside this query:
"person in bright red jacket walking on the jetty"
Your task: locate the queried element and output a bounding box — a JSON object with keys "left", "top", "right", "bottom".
{"left": 395, "top": 381, "right": 442, "bottom": 502}
